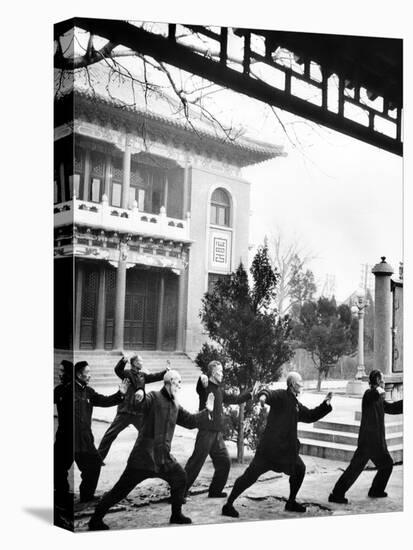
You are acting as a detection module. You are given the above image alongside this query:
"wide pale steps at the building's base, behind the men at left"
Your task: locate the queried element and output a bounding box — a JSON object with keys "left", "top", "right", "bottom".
{"left": 54, "top": 350, "right": 201, "bottom": 389}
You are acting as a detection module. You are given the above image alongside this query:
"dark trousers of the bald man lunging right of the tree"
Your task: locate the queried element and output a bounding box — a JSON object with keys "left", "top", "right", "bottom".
{"left": 228, "top": 456, "right": 305, "bottom": 504}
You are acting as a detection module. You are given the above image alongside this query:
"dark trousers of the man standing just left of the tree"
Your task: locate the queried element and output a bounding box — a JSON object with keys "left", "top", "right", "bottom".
{"left": 185, "top": 430, "right": 231, "bottom": 494}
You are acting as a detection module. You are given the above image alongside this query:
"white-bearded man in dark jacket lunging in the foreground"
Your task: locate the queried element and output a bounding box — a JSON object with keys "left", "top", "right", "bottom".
{"left": 89, "top": 370, "right": 214, "bottom": 531}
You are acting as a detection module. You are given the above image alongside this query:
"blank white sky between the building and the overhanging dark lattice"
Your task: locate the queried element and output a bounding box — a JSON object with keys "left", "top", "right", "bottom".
{"left": 244, "top": 116, "right": 402, "bottom": 300}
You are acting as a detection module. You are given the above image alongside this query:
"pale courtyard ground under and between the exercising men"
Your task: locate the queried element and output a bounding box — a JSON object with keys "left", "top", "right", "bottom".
{"left": 61, "top": 387, "right": 403, "bottom": 530}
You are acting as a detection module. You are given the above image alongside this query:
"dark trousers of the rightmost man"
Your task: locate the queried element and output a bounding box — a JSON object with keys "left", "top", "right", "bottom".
{"left": 333, "top": 447, "right": 393, "bottom": 496}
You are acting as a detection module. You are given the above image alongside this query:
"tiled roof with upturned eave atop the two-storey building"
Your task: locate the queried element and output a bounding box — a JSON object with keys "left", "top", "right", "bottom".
{"left": 56, "top": 90, "right": 287, "bottom": 167}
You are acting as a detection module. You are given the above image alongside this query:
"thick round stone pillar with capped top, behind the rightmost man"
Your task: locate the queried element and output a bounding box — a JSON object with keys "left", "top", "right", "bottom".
{"left": 372, "top": 256, "right": 393, "bottom": 375}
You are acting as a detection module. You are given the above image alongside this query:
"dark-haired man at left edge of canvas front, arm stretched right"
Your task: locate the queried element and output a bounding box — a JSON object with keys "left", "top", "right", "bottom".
{"left": 72, "top": 361, "right": 129, "bottom": 502}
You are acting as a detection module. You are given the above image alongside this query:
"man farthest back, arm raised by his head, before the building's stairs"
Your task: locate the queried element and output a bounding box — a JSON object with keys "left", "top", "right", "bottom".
{"left": 98, "top": 355, "right": 169, "bottom": 460}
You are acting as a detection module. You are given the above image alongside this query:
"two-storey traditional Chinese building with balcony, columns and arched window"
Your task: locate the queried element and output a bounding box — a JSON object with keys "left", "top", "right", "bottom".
{"left": 54, "top": 67, "right": 283, "bottom": 352}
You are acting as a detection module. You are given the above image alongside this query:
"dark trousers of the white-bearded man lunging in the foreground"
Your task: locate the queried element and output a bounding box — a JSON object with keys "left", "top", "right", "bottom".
{"left": 94, "top": 463, "right": 186, "bottom": 519}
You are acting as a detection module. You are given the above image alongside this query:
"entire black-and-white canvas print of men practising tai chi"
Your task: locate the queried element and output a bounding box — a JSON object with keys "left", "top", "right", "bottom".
{"left": 54, "top": 18, "right": 403, "bottom": 531}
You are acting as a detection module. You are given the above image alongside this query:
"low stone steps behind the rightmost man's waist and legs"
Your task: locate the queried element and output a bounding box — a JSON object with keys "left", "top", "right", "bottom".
{"left": 298, "top": 418, "right": 403, "bottom": 463}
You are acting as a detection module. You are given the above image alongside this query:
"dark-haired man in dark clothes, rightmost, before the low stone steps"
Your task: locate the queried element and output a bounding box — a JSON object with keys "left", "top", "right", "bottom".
{"left": 328, "top": 369, "right": 403, "bottom": 504}
